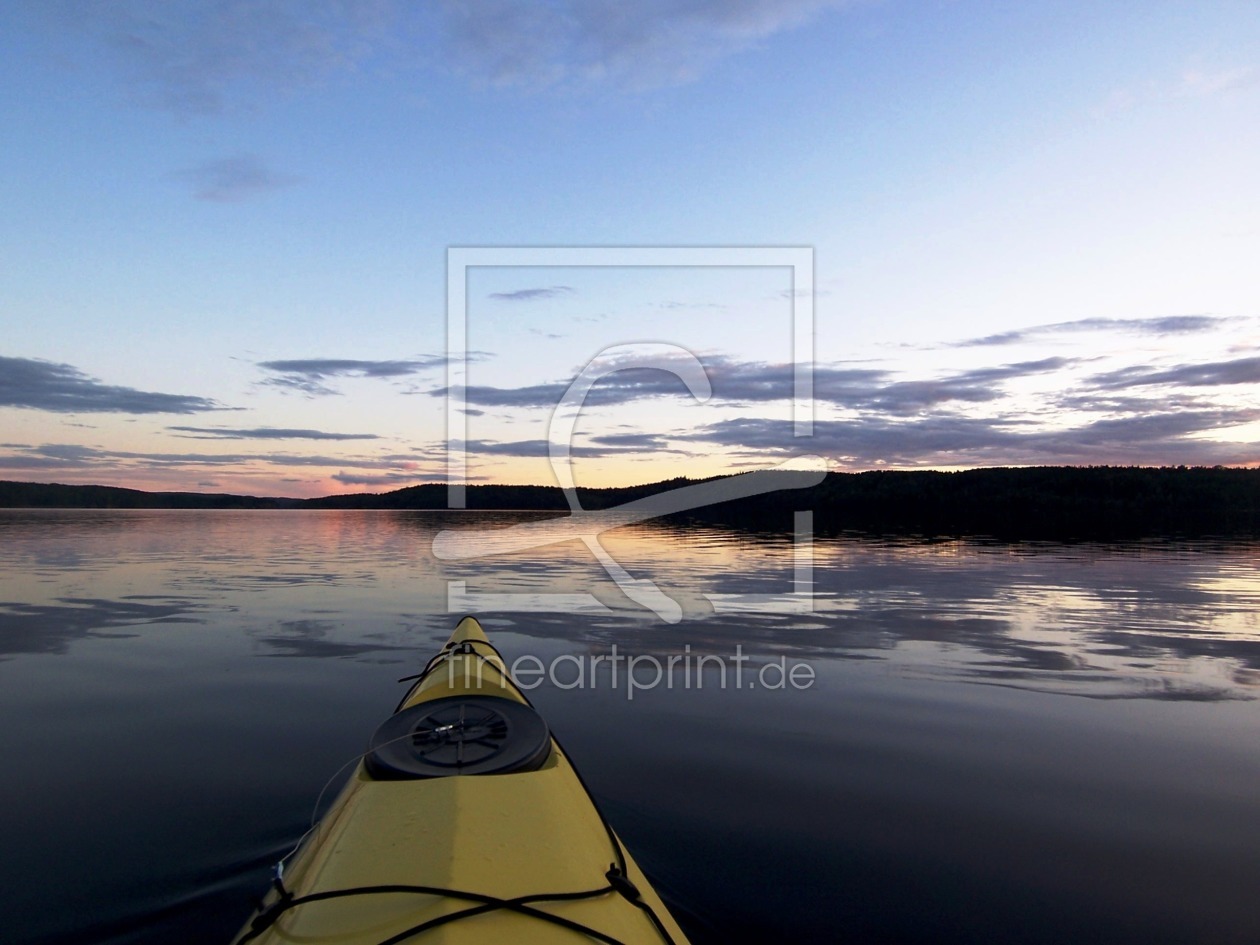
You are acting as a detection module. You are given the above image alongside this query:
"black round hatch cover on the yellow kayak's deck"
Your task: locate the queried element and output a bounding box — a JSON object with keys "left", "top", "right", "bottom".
{"left": 365, "top": 696, "right": 551, "bottom": 780}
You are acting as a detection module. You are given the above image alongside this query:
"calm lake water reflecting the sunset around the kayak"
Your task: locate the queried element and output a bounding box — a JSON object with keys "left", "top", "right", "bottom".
{"left": 0, "top": 510, "right": 1260, "bottom": 945}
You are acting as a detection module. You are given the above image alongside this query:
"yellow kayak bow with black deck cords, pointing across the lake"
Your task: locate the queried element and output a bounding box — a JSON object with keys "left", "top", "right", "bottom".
{"left": 236, "top": 617, "right": 687, "bottom": 945}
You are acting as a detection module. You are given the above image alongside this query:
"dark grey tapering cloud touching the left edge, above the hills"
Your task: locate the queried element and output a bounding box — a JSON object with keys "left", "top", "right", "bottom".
{"left": 0, "top": 357, "right": 221, "bottom": 413}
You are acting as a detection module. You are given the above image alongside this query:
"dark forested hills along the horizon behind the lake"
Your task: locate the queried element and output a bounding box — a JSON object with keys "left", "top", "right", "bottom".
{"left": 0, "top": 466, "right": 1260, "bottom": 539}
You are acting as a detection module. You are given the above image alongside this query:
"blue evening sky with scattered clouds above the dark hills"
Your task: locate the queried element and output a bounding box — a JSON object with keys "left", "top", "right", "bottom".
{"left": 0, "top": 0, "right": 1260, "bottom": 496}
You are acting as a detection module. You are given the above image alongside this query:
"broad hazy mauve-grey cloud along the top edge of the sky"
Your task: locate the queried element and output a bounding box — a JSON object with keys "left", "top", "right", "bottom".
{"left": 54, "top": 0, "right": 849, "bottom": 116}
